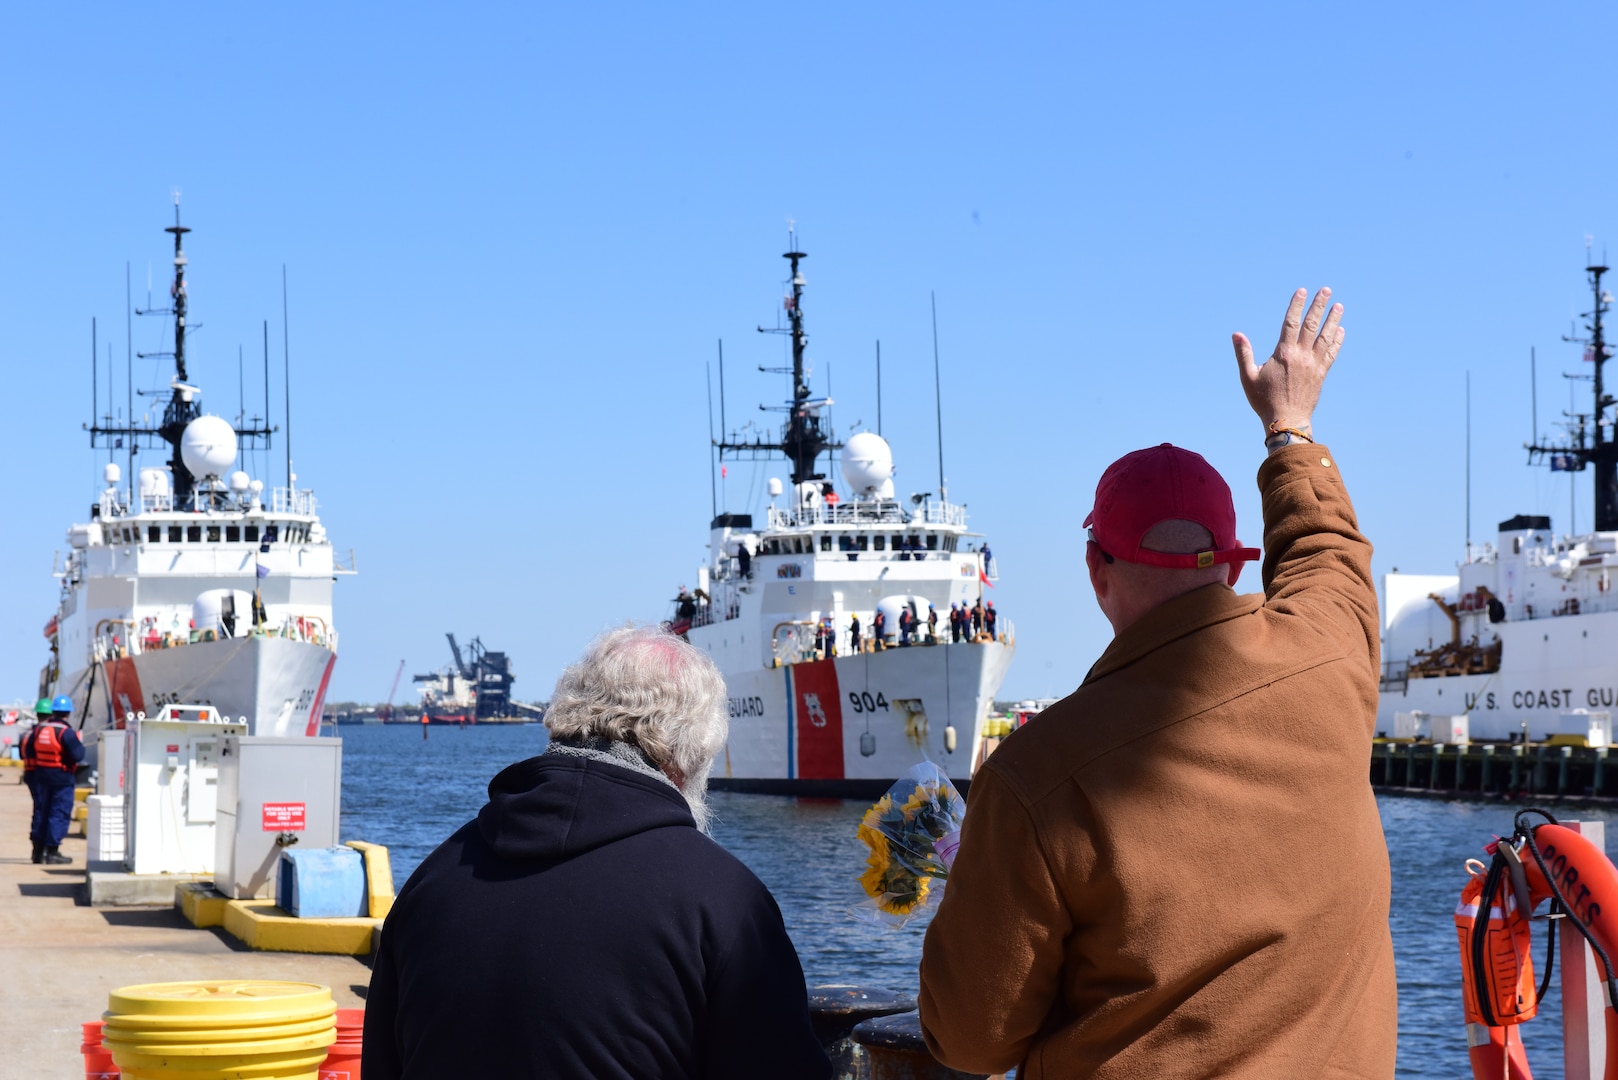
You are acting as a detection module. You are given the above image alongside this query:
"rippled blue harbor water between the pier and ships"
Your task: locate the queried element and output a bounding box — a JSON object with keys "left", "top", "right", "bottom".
{"left": 340, "top": 724, "right": 1615, "bottom": 1080}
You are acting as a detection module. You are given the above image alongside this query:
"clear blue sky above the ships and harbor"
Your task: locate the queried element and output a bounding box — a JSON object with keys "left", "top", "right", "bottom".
{"left": 0, "top": 3, "right": 1618, "bottom": 699}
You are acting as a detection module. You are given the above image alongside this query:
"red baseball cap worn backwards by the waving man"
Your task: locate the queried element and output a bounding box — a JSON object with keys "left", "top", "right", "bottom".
{"left": 1084, "top": 442, "right": 1264, "bottom": 585}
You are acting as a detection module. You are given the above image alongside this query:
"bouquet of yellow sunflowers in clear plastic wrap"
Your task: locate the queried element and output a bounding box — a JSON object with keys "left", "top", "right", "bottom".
{"left": 854, "top": 761, "right": 966, "bottom": 926}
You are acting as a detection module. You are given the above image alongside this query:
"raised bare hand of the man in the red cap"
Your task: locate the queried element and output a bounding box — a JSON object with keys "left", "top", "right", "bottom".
{"left": 1230, "top": 288, "right": 1343, "bottom": 436}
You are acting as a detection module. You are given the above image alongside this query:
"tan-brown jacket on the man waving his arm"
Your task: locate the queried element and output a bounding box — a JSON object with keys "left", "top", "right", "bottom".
{"left": 921, "top": 445, "right": 1398, "bottom": 1080}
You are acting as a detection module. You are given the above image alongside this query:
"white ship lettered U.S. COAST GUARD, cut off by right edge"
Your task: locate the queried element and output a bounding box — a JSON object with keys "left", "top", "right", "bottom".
{"left": 1377, "top": 261, "right": 1618, "bottom": 740}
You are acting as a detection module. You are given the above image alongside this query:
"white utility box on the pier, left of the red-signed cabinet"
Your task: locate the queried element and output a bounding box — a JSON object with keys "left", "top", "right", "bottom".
{"left": 123, "top": 706, "right": 248, "bottom": 874}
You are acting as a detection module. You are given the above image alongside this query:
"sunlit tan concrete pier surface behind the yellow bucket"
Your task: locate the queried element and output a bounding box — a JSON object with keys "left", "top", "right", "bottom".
{"left": 0, "top": 767, "right": 371, "bottom": 1077}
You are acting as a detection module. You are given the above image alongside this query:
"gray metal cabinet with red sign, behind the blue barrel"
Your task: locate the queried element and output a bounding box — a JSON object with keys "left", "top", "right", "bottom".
{"left": 214, "top": 735, "right": 343, "bottom": 900}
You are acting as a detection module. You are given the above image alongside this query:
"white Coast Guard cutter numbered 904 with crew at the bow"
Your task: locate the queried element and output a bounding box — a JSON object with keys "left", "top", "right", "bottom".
{"left": 675, "top": 244, "right": 1014, "bottom": 795}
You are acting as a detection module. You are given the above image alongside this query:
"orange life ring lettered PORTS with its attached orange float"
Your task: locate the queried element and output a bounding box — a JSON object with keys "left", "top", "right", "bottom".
{"left": 1455, "top": 810, "right": 1618, "bottom": 1080}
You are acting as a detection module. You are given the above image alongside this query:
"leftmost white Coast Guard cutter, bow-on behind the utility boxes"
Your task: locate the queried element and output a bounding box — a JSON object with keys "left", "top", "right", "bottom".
{"left": 40, "top": 202, "right": 353, "bottom": 735}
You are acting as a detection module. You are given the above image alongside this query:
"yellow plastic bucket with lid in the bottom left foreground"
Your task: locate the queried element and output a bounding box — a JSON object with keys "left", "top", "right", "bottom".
{"left": 102, "top": 980, "right": 337, "bottom": 1080}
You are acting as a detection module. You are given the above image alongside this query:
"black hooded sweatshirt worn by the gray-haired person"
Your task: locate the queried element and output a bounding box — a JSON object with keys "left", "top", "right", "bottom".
{"left": 362, "top": 755, "right": 832, "bottom": 1080}
